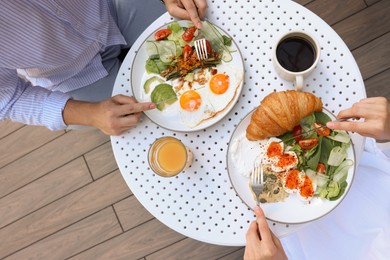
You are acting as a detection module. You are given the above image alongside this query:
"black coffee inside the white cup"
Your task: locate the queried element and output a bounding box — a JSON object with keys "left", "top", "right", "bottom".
{"left": 276, "top": 37, "right": 316, "bottom": 72}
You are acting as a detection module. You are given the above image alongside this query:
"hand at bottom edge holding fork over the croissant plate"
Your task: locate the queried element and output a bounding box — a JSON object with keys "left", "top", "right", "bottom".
{"left": 244, "top": 206, "right": 287, "bottom": 260}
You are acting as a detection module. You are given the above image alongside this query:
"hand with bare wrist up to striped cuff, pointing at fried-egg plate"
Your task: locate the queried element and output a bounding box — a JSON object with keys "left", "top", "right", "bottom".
{"left": 63, "top": 95, "right": 156, "bottom": 135}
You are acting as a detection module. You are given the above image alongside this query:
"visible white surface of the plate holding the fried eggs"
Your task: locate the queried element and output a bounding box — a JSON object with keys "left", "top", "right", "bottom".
{"left": 131, "top": 20, "right": 244, "bottom": 132}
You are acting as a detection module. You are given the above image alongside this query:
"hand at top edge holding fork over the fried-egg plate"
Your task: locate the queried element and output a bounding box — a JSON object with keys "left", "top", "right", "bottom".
{"left": 164, "top": 0, "right": 208, "bottom": 29}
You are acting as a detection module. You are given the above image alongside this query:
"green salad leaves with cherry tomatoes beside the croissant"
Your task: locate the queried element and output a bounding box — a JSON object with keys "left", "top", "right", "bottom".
{"left": 278, "top": 112, "right": 354, "bottom": 200}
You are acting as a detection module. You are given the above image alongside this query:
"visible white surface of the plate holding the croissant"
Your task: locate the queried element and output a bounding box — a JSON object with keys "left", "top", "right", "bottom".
{"left": 227, "top": 109, "right": 356, "bottom": 224}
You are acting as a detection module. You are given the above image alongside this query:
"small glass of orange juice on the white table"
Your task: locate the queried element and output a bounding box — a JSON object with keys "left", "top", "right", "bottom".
{"left": 148, "top": 136, "right": 193, "bottom": 177}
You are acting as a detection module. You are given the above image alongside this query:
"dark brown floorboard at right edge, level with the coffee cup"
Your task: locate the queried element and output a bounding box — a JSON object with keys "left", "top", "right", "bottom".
{"left": 352, "top": 33, "right": 390, "bottom": 79}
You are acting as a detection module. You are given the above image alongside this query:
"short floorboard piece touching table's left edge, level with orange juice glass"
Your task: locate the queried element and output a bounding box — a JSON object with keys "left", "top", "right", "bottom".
{"left": 84, "top": 142, "right": 118, "bottom": 180}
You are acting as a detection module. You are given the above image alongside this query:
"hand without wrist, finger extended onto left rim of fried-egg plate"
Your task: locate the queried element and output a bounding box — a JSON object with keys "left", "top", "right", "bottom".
{"left": 93, "top": 95, "right": 156, "bottom": 135}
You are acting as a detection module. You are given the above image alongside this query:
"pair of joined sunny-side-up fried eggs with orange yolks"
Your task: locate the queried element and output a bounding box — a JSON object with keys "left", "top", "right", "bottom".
{"left": 144, "top": 64, "right": 243, "bottom": 128}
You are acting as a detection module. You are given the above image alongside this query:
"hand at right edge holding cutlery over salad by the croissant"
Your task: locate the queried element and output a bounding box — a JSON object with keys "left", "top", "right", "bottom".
{"left": 326, "top": 97, "right": 390, "bottom": 140}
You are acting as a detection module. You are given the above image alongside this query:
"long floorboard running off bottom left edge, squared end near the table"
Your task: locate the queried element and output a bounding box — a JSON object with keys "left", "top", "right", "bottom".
{"left": 7, "top": 207, "right": 122, "bottom": 260}
